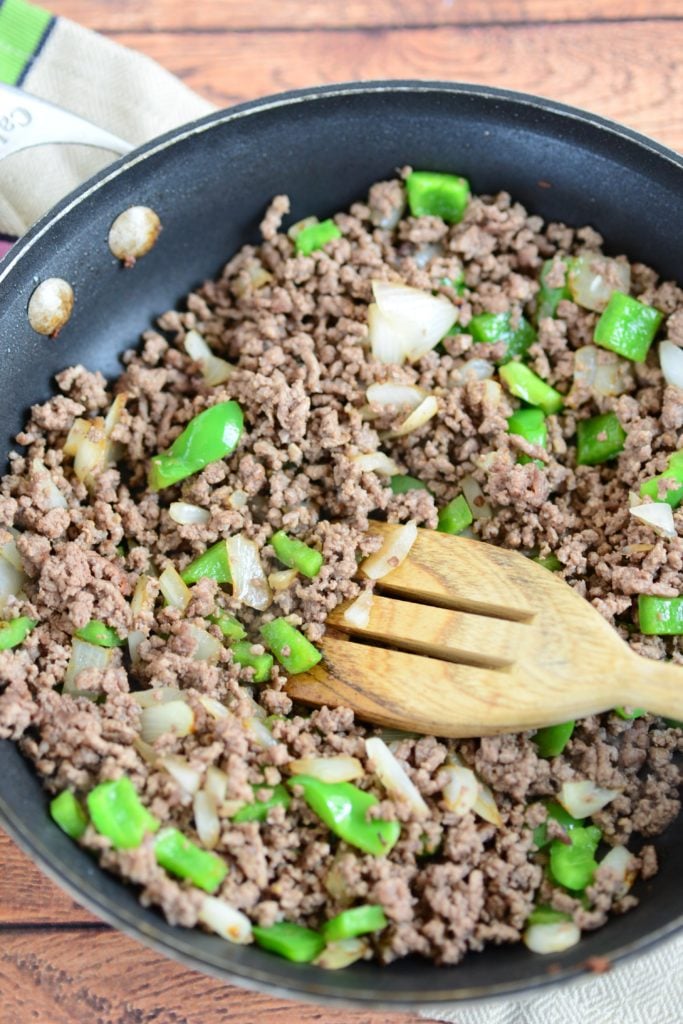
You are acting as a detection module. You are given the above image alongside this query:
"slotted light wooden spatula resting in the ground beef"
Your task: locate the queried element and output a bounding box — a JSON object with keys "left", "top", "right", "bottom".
{"left": 287, "top": 523, "right": 683, "bottom": 736}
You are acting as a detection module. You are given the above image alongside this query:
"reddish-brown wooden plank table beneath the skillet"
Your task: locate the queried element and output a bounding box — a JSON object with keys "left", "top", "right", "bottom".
{"left": 0, "top": 0, "right": 683, "bottom": 1024}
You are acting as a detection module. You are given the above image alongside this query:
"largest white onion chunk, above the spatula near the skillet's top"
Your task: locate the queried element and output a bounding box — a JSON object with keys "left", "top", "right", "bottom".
{"left": 368, "top": 281, "right": 458, "bottom": 362}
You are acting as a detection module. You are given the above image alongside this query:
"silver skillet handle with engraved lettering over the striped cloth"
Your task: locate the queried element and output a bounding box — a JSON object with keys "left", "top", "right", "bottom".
{"left": 0, "top": 82, "right": 134, "bottom": 160}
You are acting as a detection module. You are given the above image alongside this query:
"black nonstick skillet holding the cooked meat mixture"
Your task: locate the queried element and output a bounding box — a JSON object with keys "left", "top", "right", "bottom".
{"left": 0, "top": 81, "right": 683, "bottom": 1010}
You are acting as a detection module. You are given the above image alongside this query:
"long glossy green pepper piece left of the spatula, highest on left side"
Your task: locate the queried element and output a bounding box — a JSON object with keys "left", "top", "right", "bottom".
{"left": 148, "top": 401, "right": 244, "bottom": 490}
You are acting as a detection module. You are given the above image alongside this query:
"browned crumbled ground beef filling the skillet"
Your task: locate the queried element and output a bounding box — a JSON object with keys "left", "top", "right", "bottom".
{"left": 0, "top": 172, "right": 683, "bottom": 963}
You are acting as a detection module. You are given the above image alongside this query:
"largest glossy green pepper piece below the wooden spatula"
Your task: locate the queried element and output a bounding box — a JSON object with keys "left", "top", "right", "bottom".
{"left": 287, "top": 775, "right": 400, "bottom": 857}
